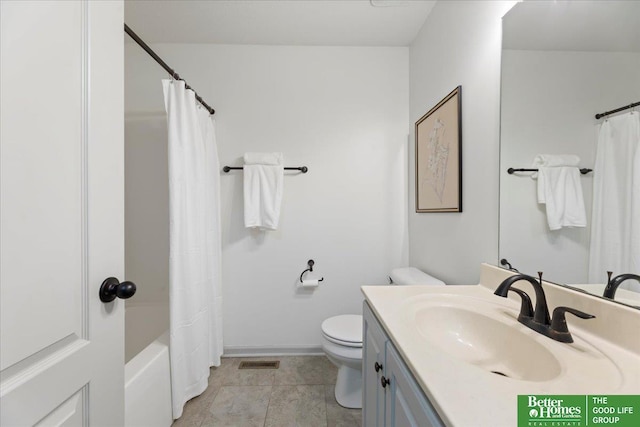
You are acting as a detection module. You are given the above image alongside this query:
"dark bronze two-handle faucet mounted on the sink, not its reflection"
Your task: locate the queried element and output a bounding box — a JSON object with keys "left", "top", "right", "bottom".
{"left": 494, "top": 272, "right": 595, "bottom": 343}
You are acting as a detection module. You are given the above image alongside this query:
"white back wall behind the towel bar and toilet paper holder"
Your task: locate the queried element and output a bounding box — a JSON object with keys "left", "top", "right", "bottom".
{"left": 126, "top": 44, "right": 408, "bottom": 353}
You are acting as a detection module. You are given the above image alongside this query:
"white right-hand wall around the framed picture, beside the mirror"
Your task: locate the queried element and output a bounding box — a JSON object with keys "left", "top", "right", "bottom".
{"left": 409, "top": 1, "right": 515, "bottom": 284}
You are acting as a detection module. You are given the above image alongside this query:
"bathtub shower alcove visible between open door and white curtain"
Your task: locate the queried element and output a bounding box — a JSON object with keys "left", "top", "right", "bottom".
{"left": 124, "top": 39, "right": 173, "bottom": 426}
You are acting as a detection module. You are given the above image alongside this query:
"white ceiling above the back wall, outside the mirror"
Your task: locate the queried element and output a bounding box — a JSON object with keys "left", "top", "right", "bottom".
{"left": 125, "top": 0, "right": 436, "bottom": 46}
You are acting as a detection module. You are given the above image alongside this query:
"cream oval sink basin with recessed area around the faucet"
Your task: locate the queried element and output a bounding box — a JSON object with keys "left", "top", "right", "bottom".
{"left": 399, "top": 294, "right": 620, "bottom": 386}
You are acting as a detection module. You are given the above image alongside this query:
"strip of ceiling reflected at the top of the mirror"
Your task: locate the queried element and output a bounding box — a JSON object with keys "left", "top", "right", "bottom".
{"left": 503, "top": 0, "right": 640, "bottom": 52}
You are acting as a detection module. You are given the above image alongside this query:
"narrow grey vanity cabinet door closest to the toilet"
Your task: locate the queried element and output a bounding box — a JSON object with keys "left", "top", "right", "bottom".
{"left": 362, "top": 303, "right": 387, "bottom": 427}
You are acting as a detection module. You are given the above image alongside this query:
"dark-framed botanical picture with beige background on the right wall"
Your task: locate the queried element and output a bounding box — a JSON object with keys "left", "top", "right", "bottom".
{"left": 415, "top": 86, "right": 462, "bottom": 213}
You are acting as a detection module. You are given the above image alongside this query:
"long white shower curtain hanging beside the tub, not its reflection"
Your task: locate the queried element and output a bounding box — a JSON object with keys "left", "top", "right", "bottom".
{"left": 162, "top": 80, "right": 222, "bottom": 418}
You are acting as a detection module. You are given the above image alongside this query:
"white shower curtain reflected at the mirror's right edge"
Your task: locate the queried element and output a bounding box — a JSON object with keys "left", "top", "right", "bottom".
{"left": 589, "top": 111, "right": 640, "bottom": 292}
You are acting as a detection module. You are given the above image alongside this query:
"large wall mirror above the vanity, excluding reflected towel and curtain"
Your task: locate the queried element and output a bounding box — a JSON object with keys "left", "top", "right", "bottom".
{"left": 499, "top": 1, "right": 640, "bottom": 307}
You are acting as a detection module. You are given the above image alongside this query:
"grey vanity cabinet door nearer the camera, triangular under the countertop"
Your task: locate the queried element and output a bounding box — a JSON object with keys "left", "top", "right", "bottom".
{"left": 382, "top": 342, "right": 444, "bottom": 427}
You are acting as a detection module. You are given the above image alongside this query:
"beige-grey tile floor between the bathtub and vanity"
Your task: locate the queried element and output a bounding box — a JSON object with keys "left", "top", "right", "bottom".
{"left": 172, "top": 356, "right": 362, "bottom": 427}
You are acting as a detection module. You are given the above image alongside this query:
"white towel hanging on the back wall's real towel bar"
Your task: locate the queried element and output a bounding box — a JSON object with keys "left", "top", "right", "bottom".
{"left": 244, "top": 153, "right": 284, "bottom": 230}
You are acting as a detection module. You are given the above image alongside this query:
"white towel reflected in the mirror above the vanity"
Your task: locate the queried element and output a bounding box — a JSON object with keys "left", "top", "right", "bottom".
{"left": 533, "top": 154, "right": 587, "bottom": 230}
